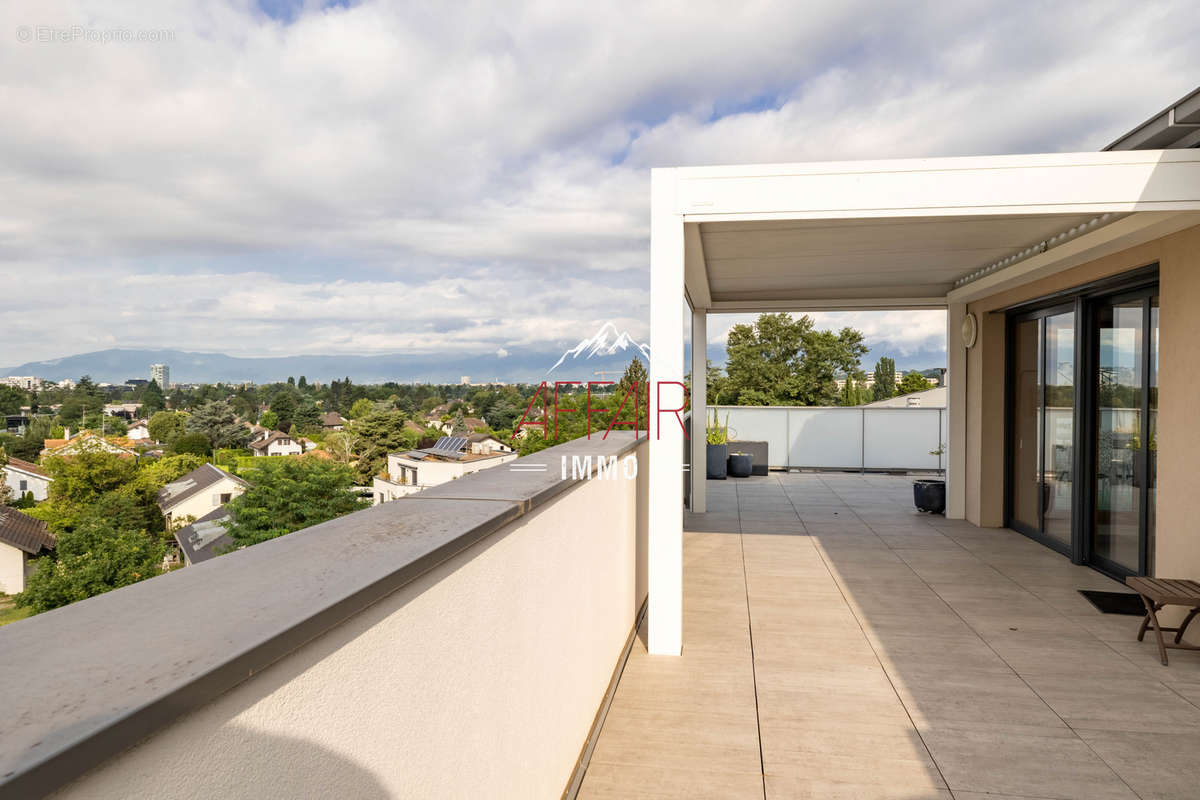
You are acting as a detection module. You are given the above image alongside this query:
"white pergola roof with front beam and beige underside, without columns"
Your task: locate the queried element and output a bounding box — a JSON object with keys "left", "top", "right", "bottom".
{"left": 674, "top": 150, "right": 1200, "bottom": 311}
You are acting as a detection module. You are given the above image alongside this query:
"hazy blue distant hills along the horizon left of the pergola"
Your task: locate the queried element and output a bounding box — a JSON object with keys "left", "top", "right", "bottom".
{"left": 0, "top": 349, "right": 648, "bottom": 384}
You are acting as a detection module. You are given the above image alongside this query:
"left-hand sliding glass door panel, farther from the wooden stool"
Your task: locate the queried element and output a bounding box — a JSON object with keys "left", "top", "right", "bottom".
{"left": 1008, "top": 307, "right": 1076, "bottom": 554}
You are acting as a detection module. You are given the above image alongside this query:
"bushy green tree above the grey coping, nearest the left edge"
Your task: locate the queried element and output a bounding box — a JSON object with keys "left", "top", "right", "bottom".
{"left": 16, "top": 510, "right": 166, "bottom": 612}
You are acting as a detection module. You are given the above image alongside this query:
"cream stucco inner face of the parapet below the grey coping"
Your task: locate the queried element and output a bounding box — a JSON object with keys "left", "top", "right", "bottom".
{"left": 55, "top": 445, "right": 648, "bottom": 800}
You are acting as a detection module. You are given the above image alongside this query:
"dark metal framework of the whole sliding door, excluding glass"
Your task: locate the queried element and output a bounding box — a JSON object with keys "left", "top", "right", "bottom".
{"left": 994, "top": 261, "right": 1159, "bottom": 578}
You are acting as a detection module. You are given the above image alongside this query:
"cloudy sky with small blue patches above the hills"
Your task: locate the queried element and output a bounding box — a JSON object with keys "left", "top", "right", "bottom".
{"left": 0, "top": 0, "right": 1200, "bottom": 376}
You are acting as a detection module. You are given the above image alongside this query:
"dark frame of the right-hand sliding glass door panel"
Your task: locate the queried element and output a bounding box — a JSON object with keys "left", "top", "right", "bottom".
{"left": 1080, "top": 284, "right": 1159, "bottom": 579}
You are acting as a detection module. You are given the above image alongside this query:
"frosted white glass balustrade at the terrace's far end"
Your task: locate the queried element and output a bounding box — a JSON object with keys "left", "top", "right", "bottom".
{"left": 716, "top": 405, "right": 949, "bottom": 470}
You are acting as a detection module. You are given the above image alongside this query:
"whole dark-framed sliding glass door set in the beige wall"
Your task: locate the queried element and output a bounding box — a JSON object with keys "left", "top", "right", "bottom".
{"left": 1004, "top": 265, "right": 1158, "bottom": 577}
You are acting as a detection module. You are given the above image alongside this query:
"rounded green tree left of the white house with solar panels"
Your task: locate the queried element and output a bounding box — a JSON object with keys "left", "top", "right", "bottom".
{"left": 227, "top": 458, "right": 368, "bottom": 547}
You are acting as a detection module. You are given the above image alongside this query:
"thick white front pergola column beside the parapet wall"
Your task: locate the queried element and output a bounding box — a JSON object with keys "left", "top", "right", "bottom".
{"left": 648, "top": 169, "right": 685, "bottom": 656}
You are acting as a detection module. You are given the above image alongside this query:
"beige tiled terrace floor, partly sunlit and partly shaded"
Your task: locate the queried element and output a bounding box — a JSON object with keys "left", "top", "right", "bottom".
{"left": 580, "top": 474, "right": 1200, "bottom": 800}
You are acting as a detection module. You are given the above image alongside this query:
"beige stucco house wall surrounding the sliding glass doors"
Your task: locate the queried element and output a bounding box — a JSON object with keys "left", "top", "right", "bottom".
{"left": 966, "top": 227, "right": 1200, "bottom": 579}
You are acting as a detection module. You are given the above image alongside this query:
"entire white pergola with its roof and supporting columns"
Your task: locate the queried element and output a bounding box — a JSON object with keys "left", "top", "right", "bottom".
{"left": 649, "top": 149, "right": 1200, "bottom": 655}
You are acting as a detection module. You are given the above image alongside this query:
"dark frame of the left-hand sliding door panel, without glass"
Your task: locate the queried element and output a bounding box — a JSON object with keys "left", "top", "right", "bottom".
{"left": 1004, "top": 299, "right": 1081, "bottom": 561}
